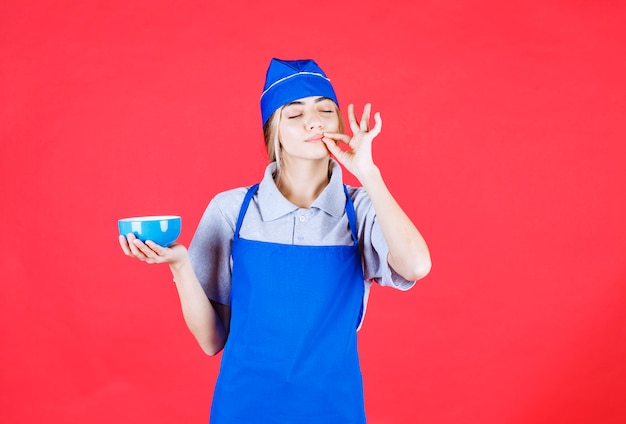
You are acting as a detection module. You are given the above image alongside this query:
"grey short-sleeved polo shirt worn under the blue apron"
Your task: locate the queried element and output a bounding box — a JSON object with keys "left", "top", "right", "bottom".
{"left": 189, "top": 160, "right": 415, "bottom": 328}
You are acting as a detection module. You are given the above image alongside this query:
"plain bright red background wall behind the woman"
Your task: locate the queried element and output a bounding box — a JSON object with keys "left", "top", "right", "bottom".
{"left": 0, "top": 0, "right": 626, "bottom": 424}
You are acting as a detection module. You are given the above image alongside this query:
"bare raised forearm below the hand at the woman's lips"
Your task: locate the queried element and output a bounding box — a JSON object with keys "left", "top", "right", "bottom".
{"left": 359, "top": 166, "right": 431, "bottom": 281}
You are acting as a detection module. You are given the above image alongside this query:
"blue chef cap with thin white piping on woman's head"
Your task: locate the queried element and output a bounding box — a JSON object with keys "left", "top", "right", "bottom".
{"left": 261, "top": 59, "right": 339, "bottom": 125}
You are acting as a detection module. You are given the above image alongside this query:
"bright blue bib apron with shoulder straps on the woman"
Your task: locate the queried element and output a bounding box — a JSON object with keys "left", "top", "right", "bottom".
{"left": 210, "top": 184, "right": 365, "bottom": 424}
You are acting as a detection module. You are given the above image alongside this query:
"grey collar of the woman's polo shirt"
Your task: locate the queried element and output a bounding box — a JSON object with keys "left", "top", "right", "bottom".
{"left": 258, "top": 159, "right": 346, "bottom": 221}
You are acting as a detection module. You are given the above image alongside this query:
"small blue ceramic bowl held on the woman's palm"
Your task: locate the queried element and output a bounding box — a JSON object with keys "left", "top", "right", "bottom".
{"left": 117, "top": 215, "right": 181, "bottom": 247}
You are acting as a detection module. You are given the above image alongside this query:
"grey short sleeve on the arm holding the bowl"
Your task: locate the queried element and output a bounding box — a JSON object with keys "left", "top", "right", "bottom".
{"left": 189, "top": 188, "right": 246, "bottom": 305}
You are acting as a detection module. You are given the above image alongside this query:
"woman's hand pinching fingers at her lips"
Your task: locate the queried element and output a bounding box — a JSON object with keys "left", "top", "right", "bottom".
{"left": 322, "top": 103, "right": 383, "bottom": 182}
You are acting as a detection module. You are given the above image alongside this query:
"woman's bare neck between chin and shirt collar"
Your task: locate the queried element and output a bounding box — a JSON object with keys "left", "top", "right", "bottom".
{"left": 276, "top": 159, "right": 330, "bottom": 208}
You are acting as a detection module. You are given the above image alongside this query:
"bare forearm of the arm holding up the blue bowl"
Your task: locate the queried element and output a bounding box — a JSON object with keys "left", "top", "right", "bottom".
{"left": 170, "top": 257, "right": 227, "bottom": 355}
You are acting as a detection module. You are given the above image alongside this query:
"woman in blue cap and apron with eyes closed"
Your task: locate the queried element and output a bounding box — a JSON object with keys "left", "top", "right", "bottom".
{"left": 120, "top": 59, "right": 430, "bottom": 423}
